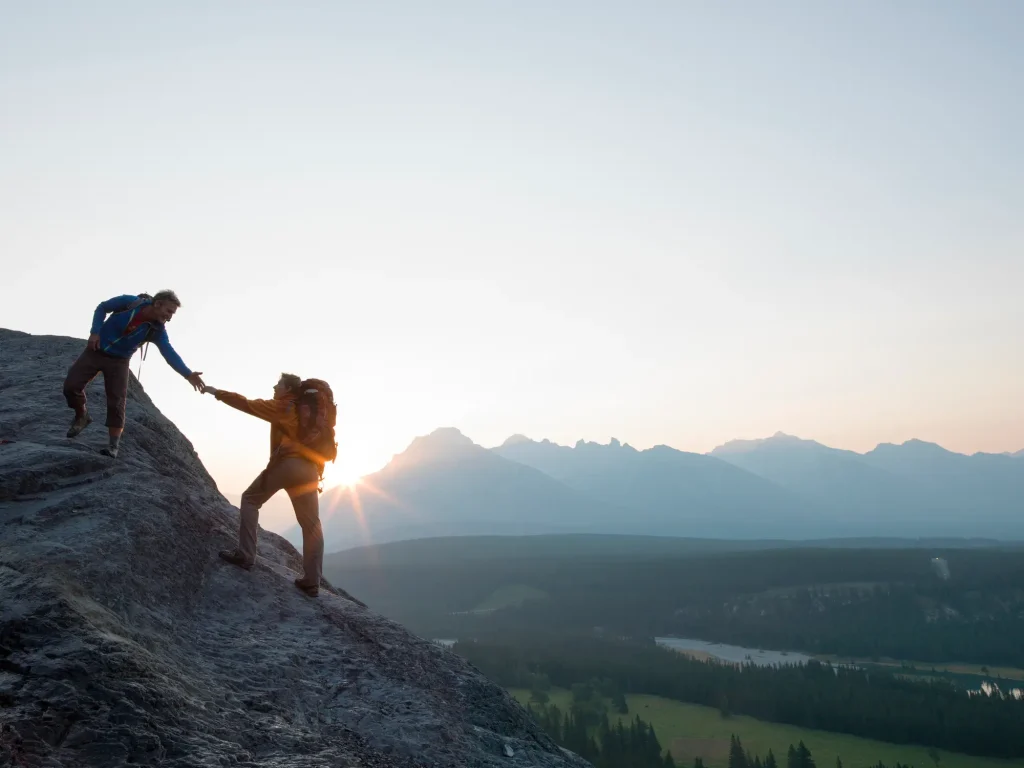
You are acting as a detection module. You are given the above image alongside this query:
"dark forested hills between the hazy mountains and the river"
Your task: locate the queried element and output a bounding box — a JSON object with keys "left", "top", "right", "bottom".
{"left": 345, "top": 549, "right": 1024, "bottom": 668}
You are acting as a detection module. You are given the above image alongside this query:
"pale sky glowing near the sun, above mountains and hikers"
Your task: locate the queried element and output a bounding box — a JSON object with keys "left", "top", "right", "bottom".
{"left": 0, "top": 0, "right": 1024, "bottom": 525}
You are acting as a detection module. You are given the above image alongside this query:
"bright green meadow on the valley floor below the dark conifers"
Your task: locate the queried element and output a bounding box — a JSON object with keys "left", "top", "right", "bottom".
{"left": 511, "top": 689, "right": 1024, "bottom": 768}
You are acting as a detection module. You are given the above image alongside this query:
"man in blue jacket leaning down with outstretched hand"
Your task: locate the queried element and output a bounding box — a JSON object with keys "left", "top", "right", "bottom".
{"left": 63, "top": 291, "right": 206, "bottom": 458}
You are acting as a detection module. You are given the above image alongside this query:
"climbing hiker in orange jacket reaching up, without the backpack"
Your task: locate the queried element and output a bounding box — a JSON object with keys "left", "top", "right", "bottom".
{"left": 206, "top": 374, "right": 324, "bottom": 597}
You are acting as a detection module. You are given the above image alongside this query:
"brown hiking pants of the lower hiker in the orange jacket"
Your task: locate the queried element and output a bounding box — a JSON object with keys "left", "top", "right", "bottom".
{"left": 239, "top": 457, "right": 324, "bottom": 586}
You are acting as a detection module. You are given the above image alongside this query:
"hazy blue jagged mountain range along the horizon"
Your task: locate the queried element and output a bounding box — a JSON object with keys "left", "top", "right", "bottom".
{"left": 307, "top": 428, "right": 1024, "bottom": 552}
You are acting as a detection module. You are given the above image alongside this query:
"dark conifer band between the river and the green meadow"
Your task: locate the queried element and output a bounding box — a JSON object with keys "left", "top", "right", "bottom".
{"left": 456, "top": 635, "right": 1024, "bottom": 758}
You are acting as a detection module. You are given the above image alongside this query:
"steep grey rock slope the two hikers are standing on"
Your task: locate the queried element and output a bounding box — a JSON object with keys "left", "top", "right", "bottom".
{"left": 0, "top": 329, "right": 587, "bottom": 768}
